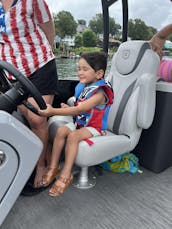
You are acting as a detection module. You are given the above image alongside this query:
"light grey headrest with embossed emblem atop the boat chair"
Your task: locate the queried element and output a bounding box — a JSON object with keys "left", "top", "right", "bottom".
{"left": 115, "top": 41, "right": 151, "bottom": 75}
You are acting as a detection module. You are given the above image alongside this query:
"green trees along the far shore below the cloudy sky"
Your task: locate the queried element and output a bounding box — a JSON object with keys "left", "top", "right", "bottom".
{"left": 53, "top": 11, "right": 172, "bottom": 47}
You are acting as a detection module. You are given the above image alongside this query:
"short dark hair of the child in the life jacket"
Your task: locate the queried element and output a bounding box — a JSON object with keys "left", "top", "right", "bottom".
{"left": 80, "top": 52, "right": 107, "bottom": 72}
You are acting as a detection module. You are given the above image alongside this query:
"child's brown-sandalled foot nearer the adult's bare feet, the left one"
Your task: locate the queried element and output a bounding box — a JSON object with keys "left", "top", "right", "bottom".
{"left": 41, "top": 166, "right": 60, "bottom": 187}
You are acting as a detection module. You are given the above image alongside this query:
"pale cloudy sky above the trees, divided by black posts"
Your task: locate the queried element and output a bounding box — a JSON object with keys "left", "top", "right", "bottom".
{"left": 45, "top": 0, "right": 172, "bottom": 30}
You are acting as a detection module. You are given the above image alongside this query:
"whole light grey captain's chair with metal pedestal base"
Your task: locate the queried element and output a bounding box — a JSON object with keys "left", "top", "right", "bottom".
{"left": 49, "top": 41, "right": 160, "bottom": 188}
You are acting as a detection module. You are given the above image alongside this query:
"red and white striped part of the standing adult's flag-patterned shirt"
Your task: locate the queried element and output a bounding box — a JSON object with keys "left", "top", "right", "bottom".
{"left": 0, "top": 0, "right": 54, "bottom": 77}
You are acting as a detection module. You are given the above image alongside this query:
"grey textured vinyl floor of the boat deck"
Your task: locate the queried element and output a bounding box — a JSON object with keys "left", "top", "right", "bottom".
{"left": 1, "top": 167, "right": 172, "bottom": 229}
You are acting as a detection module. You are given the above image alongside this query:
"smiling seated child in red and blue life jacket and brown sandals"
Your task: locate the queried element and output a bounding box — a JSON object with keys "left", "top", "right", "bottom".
{"left": 39, "top": 52, "right": 113, "bottom": 196}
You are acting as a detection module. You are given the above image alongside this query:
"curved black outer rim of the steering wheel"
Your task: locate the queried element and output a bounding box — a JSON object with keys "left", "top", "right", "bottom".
{"left": 0, "top": 61, "right": 46, "bottom": 113}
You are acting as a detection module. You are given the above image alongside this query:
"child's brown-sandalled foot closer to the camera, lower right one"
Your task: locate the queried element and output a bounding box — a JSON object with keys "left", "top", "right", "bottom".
{"left": 49, "top": 174, "right": 73, "bottom": 196}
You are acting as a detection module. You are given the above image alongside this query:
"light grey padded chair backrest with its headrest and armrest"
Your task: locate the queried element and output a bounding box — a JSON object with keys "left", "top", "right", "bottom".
{"left": 107, "top": 41, "right": 160, "bottom": 148}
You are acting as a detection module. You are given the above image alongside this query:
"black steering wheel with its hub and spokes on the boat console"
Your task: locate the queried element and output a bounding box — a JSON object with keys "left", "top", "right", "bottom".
{"left": 0, "top": 61, "right": 46, "bottom": 115}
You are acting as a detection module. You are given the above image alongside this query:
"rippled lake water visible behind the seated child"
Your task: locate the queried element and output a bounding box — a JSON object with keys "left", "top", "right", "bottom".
{"left": 56, "top": 56, "right": 172, "bottom": 80}
